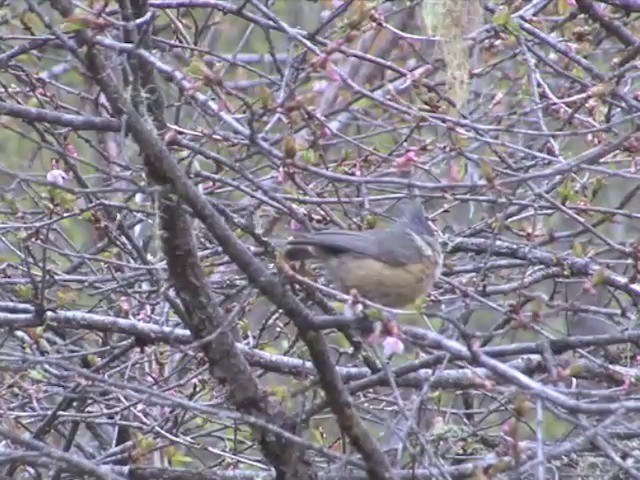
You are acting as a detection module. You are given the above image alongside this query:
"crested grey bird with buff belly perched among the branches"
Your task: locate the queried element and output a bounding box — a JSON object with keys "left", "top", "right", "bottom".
{"left": 284, "top": 200, "right": 443, "bottom": 344}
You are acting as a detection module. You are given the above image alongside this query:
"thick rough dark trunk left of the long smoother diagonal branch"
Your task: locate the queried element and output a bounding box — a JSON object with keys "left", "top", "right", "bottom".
{"left": 43, "top": 1, "right": 314, "bottom": 474}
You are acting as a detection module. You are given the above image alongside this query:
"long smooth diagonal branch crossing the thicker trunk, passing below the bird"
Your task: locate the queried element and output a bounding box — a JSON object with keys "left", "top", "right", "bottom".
{"left": 46, "top": 0, "right": 393, "bottom": 480}
